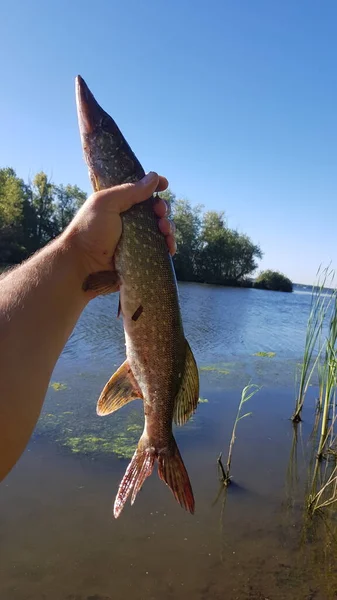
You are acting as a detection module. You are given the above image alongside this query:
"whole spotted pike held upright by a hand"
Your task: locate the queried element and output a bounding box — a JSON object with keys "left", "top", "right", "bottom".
{"left": 76, "top": 76, "right": 199, "bottom": 518}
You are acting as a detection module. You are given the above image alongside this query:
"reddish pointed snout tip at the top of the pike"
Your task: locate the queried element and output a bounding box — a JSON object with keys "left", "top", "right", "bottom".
{"left": 75, "top": 75, "right": 106, "bottom": 135}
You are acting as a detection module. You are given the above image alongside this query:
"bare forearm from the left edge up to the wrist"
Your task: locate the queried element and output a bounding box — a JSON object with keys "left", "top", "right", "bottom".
{"left": 0, "top": 236, "right": 88, "bottom": 480}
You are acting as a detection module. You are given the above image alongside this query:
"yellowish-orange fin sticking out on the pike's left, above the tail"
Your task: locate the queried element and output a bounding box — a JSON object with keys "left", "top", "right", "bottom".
{"left": 96, "top": 360, "right": 143, "bottom": 416}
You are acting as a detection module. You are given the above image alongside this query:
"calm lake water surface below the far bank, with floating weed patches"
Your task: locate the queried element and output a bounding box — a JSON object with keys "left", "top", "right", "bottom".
{"left": 0, "top": 284, "right": 337, "bottom": 600}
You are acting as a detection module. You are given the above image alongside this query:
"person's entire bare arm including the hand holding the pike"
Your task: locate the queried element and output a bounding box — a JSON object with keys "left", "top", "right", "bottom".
{"left": 0, "top": 174, "right": 175, "bottom": 481}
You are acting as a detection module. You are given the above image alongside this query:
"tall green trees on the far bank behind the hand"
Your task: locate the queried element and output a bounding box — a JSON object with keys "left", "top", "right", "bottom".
{"left": 0, "top": 168, "right": 262, "bottom": 285}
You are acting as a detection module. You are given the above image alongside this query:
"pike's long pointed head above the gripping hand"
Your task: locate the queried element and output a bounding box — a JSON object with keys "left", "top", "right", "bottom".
{"left": 76, "top": 75, "right": 145, "bottom": 191}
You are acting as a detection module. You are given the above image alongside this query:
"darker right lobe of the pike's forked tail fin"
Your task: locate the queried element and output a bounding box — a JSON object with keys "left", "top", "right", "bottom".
{"left": 158, "top": 436, "right": 194, "bottom": 515}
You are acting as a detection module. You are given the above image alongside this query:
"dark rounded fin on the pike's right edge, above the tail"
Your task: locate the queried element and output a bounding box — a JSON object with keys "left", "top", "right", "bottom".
{"left": 173, "top": 340, "right": 199, "bottom": 425}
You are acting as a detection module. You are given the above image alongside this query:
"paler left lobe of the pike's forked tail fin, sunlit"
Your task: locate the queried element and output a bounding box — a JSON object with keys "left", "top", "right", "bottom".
{"left": 114, "top": 435, "right": 156, "bottom": 519}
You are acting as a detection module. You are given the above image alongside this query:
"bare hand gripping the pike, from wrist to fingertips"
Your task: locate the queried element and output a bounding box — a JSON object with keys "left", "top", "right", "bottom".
{"left": 64, "top": 172, "right": 176, "bottom": 293}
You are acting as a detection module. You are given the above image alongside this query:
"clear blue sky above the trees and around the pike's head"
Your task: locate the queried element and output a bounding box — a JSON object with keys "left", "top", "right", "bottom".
{"left": 0, "top": 0, "right": 337, "bottom": 283}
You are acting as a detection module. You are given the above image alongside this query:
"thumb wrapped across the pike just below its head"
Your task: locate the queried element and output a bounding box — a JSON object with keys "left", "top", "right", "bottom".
{"left": 99, "top": 172, "right": 160, "bottom": 213}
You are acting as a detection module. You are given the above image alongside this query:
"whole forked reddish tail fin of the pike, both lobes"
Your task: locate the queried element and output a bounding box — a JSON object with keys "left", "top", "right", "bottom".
{"left": 114, "top": 434, "right": 194, "bottom": 519}
